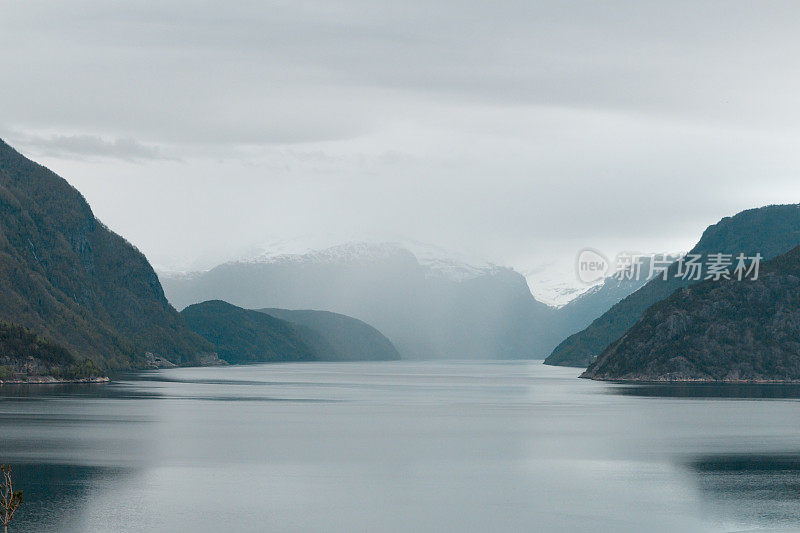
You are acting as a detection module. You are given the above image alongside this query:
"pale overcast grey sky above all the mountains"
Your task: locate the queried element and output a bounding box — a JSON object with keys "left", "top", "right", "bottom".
{"left": 0, "top": 0, "right": 800, "bottom": 300}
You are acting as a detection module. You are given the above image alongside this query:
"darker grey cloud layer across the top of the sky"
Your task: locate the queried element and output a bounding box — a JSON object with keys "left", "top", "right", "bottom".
{"left": 0, "top": 0, "right": 800, "bottom": 145}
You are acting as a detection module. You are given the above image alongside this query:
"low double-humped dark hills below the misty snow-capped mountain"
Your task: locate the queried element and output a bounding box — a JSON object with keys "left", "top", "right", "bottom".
{"left": 181, "top": 300, "right": 399, "bottom": 363}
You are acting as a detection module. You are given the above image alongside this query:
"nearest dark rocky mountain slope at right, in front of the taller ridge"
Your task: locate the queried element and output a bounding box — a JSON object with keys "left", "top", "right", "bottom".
{"left": 581, "top": 247, "right": 800, "bottom": 382}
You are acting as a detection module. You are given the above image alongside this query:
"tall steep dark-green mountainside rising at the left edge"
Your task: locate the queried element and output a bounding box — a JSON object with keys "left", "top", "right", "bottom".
{"left": 0, "top": 137, "right": 215, "bottom": 369}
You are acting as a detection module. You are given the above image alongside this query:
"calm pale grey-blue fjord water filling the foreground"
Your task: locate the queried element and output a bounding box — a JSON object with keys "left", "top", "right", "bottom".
{"left": 0, "top": 362, "right": 800, "bottom": 532}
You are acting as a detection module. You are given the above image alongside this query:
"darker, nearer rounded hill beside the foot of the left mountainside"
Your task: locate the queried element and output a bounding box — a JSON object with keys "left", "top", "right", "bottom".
{"left": 181, "top": 300, "right": 321, "bottom": 363}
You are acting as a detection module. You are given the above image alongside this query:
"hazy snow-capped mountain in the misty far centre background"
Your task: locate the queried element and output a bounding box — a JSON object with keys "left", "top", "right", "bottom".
{"left": 162, "top": 243, "right": 560, "bottom": 359}
